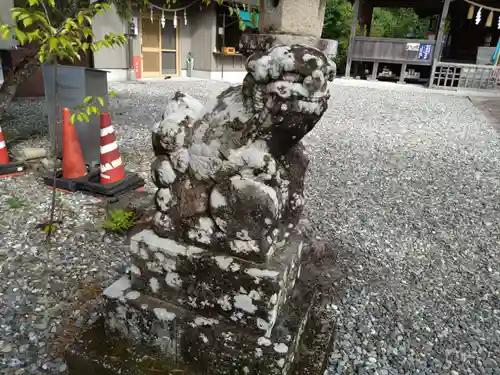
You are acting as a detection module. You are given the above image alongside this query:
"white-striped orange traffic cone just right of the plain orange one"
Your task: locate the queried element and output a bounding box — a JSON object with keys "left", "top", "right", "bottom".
{"left": 100, "top": 112, "right": 125, "bottom": 184}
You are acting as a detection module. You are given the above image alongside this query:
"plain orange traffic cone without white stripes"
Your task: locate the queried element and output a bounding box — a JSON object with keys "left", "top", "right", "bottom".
{"left": 62, "top": 108, "right": 87, "bottom": 179}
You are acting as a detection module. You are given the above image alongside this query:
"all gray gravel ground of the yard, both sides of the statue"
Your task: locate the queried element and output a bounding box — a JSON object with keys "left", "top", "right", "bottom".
{"left": 0, "top": 81, "right": 500, "bottom": 375}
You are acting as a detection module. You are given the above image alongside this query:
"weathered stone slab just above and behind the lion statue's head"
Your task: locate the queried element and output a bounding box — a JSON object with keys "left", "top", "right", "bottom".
{"left": 240, "top": 34, "right": 339, "bottom": 60}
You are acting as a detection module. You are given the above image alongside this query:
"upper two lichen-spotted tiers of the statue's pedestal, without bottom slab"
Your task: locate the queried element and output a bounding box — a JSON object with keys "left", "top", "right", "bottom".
{"left": 100, "top": 230, "right": 314, "bottom": 375}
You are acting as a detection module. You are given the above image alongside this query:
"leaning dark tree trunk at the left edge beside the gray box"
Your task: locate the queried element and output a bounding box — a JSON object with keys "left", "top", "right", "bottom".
{"left": 0, "top": 52, "right": 41, "bottom": 121}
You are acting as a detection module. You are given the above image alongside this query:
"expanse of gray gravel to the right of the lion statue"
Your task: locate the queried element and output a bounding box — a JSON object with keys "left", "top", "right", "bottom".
{"left": 306, "top": 88, "right": 500, "bottom": 375}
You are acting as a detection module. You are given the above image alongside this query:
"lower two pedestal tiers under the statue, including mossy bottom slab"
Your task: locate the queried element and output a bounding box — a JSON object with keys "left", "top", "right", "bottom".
{"left": 66, "top": 244, "right": 336, "bottom": 375}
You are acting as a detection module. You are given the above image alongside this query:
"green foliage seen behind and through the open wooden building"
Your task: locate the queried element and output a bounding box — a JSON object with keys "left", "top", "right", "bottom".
{"left": 323, "top": 0, "right": 429, "bottom": 72}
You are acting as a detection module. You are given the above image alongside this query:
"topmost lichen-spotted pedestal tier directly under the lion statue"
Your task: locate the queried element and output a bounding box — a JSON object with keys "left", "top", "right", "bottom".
{"left": 130, "top": 230, "right": 304, "bottom": 334}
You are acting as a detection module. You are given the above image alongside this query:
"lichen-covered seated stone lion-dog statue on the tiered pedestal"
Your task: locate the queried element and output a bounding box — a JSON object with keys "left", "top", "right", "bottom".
{"left": 152, "top": 45, "right": 336, "bottom": 261}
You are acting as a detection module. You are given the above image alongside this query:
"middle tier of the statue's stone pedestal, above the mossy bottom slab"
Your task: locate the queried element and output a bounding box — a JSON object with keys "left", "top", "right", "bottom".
{"left": 100, "top": 277, "right": 314, "bottom": 375}
